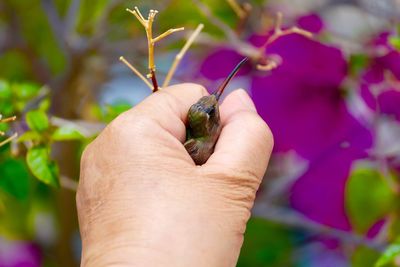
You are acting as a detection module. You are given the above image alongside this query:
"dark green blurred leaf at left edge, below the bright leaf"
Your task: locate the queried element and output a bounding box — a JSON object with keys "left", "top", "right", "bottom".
{"left": 0, "top": 159, "right": 29, "bottom": 200}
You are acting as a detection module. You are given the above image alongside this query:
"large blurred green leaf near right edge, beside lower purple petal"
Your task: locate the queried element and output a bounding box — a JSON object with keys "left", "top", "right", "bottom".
{"left": 345, "top": 169, "right": 395, "bottom": 233}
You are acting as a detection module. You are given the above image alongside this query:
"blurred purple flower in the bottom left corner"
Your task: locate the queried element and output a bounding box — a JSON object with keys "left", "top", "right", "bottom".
{"left": 0, "top": 238, "right": 42, "bottom": 267}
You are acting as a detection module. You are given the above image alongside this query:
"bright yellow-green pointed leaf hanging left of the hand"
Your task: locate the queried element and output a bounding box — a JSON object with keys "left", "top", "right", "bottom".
{"left": 26, "top": 146, "right": 59, "bottom": 187}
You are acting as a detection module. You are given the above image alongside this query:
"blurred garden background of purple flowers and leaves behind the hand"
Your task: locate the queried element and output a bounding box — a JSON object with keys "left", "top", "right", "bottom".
{"left": 0, "top": 0, "right": 400, "bottom": 267}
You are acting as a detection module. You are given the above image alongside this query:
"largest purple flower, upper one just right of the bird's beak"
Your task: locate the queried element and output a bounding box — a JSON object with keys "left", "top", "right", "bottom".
{"left": 252, "top": 35, "right": 371, "bottom": 159}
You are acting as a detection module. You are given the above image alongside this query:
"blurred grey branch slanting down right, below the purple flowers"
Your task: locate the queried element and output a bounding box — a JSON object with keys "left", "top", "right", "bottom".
{"left": 253, "top": 202, "right": 386, "bottom": 251}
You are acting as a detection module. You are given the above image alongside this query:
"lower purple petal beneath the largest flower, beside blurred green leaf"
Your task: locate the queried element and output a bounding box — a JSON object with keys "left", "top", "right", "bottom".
{"left": 290, "top": 148, "right": 354, "bottom": 230}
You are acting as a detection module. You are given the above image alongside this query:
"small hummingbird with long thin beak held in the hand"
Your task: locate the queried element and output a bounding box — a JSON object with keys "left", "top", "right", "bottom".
{"left": 184, "top": 57, "right": 248, "bottom": 165}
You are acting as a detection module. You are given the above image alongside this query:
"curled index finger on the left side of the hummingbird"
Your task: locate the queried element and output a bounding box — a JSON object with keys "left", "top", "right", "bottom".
{"left": 127, "top": 83, "right": 208, "bottom": 142}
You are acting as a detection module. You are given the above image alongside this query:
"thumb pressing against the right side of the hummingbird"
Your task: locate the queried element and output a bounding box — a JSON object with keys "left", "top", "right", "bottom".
{"left": 206, "top": 89, "right": 273, "bottom": 179}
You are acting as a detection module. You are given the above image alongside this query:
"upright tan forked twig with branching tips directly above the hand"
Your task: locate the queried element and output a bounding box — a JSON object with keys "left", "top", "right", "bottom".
{"left": 127, "top": 7, "right": 184, "bottom": 92}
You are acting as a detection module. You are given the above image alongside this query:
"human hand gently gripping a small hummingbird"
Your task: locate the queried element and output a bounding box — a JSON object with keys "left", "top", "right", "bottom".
{"left": 77, "top": 84, "right": 273, "bottom": 267}
